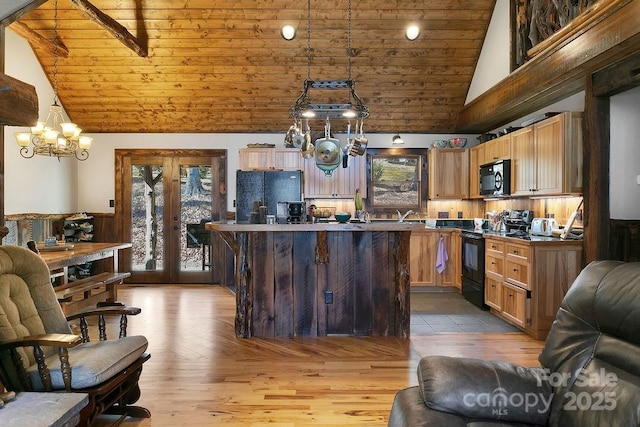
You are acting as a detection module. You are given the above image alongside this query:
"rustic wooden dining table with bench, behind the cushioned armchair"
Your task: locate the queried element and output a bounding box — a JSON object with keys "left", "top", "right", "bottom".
{"left": 40, "top": 242, "right": 131, "bottom": 314}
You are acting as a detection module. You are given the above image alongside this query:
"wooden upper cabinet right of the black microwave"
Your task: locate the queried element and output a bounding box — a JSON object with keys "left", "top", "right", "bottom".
{"left": 511, "top": 112, "right": 582, "bottom": 196}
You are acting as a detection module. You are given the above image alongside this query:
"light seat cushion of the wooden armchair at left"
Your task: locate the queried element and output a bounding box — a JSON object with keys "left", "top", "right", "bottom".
{"left": 27, "top": 336, "right": 148, "bottom": 391}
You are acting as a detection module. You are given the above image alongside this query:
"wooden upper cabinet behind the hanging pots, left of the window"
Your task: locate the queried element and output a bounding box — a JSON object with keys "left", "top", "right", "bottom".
{"left": 304, "top": 156, "right": 367, "bottom": 199}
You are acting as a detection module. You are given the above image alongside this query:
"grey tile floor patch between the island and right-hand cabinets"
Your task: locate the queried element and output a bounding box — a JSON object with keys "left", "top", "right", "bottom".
{"left": 411, "top": 291, "right": 521, "bottom": 336}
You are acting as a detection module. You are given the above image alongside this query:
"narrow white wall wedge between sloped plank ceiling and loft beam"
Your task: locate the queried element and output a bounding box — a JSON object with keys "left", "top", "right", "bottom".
{"left": 465, "top": 0, "right": 511, "bottom": 104}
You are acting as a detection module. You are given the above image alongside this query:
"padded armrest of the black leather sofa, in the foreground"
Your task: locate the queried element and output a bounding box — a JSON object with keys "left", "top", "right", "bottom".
{"left": 418, "top": 356, "right": 553, "bottom": 425}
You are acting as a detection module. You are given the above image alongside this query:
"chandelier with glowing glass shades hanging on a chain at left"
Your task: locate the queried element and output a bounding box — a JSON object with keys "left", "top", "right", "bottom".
{"left": 15, "top": 0, "right": 93, "bottom": 160}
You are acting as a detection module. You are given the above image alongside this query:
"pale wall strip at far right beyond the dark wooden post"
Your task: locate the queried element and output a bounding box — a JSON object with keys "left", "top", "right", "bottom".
{"left": 609, "top": 87, "right": 640, "bottom": 220}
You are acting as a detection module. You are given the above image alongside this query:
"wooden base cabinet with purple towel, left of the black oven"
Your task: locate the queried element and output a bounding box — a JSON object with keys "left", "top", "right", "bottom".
{"left": 409, "top": 229, "right": 461, "bottom": 288}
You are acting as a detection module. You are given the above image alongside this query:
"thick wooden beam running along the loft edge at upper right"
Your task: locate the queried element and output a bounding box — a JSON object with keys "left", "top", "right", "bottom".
{"left": 457, "top": 0, "right": 640, "bottom": 133}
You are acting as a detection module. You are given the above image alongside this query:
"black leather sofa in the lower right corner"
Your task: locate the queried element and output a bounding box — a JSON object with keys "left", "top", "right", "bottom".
{"left": 388, "top": 261, "right": 640, "bottom": 427}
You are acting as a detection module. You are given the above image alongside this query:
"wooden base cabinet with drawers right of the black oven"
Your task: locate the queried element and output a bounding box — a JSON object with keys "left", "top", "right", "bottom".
{"left": 485, "top": 237, "right": 582, "bottom": 339}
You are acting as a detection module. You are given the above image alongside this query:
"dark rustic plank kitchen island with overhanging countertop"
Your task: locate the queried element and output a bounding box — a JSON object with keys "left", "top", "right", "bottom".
{"left": 205, "top": 222, "right": 420, "bottom": 338}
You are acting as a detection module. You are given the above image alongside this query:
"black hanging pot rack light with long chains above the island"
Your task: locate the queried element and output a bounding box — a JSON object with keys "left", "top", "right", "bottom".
{"left": 290, "top": 0, "right": 369, "bottom": 123}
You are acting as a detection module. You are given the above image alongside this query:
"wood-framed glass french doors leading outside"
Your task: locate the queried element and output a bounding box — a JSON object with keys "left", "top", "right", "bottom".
{"left": 115, "top": 149, "right": 226, "bottom": 284}
